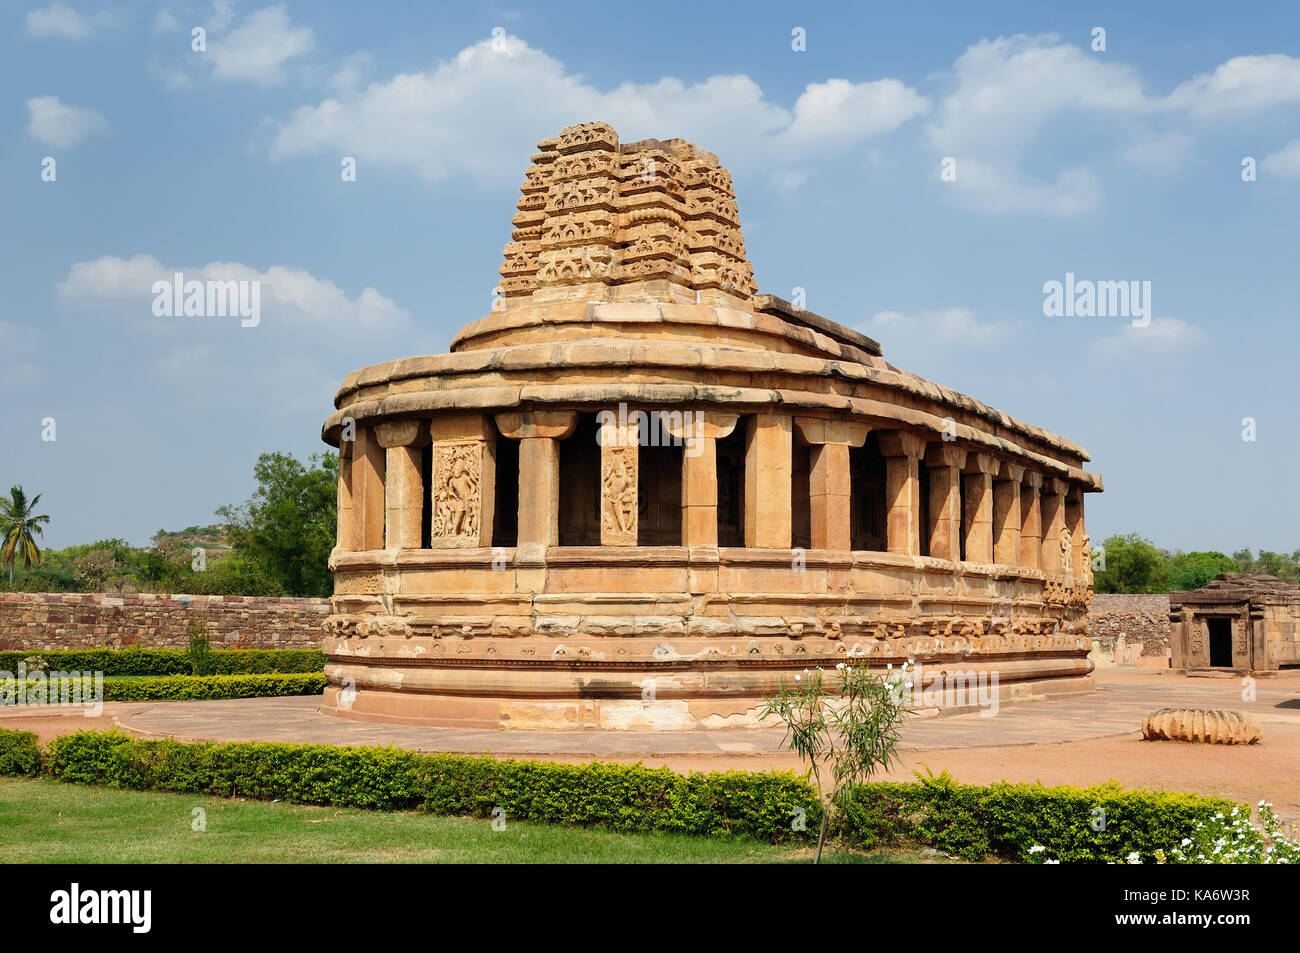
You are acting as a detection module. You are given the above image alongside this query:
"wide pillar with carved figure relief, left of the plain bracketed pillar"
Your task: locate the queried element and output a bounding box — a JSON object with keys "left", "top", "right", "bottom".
{"left": 429, "top": 413, "right": 497, "bottom": 549}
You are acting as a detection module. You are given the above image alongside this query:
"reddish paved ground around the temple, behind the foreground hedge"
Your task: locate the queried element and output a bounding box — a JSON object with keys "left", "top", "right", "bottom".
{"left": 0, "top": 668, "right": 1300, "bottom": 818}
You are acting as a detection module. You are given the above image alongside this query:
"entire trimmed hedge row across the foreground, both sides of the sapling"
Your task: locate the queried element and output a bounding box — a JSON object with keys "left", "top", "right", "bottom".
{"left": 0, "top": 729, "right": 1235, "bottom": 863}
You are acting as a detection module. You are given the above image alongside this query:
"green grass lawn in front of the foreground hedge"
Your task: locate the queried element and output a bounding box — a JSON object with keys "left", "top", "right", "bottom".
{"left": 0, "top": 779, "right": 943, "bottom": 863}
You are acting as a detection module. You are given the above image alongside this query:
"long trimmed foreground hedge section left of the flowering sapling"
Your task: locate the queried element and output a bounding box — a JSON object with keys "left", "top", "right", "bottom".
{"left": 46, "top": 732, "right": 820, "bottom": 841}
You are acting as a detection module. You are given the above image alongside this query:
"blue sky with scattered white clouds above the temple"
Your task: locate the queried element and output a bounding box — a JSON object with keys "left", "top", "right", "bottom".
{"left": 0, "top": 0, "right": 1300, "bottom": 551}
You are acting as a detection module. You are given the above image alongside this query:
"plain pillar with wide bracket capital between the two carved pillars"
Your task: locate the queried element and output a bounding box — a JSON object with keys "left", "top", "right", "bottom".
{"left": 497, "top": 411, "right": 577, "bottom": 564}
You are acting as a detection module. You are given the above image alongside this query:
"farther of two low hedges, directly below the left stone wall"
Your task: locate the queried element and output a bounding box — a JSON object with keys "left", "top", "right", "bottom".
{"left": 0, "top": 647, "right": 325, "bottom": 679}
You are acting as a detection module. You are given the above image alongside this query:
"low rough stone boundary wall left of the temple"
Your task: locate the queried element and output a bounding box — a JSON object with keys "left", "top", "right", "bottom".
{"left": 0, "top": 593, "right": 329, "bottom": 650}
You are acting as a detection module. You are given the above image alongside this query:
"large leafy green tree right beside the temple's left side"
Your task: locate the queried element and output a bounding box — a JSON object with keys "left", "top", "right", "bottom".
{"left": 217, "top": 452, "right": 338, "bottom": 595}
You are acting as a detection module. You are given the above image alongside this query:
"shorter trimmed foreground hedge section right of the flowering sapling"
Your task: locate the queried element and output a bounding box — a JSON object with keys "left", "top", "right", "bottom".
{"left": 833, "top": 771, "right": 1238, "bottom": 863}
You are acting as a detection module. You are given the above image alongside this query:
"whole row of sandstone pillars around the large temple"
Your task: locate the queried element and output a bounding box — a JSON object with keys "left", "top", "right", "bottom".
{"left": 338, "top": 411, "right": 1084, "bottom": 573}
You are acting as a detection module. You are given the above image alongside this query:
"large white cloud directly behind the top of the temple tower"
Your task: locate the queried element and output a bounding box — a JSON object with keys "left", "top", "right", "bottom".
{"left": 270, "top": 36, "right": 928, "bottom": 182}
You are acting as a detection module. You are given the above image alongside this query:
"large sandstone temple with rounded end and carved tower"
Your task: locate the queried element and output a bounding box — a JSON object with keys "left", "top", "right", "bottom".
{"left": 322, "top": 122, "right": 1101, "bottom": 729}
